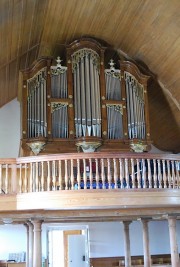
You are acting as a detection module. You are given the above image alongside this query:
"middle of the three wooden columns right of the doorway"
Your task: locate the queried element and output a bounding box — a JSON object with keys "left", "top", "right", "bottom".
{"left": 141, "top": 220, "right": 151, "bottom": 267}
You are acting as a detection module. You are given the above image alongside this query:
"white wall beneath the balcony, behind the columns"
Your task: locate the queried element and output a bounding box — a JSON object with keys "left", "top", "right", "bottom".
{"left": 0, "top": 220, "right": 180, "bottom": 259}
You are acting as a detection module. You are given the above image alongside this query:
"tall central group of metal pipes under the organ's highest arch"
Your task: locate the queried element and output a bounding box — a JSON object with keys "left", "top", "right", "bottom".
{"left": 72, "top": 48, "right": 101, "bottom": 137}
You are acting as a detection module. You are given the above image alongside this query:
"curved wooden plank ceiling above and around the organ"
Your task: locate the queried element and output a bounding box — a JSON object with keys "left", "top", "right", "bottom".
{"left": 0, "top": 0, "right": 180, "bottom": 153}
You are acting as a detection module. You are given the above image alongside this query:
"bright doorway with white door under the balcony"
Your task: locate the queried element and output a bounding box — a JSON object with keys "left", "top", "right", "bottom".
{"left": 47, "top": 226, "right": 89, "bottom": 267}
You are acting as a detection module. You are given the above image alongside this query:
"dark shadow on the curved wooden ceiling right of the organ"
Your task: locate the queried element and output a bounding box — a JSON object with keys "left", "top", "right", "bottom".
{"left": 136, "top": 60, "right": 180, "bottom": 153}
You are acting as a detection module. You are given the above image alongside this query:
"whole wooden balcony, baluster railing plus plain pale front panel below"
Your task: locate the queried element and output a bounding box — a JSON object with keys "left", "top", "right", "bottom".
{"left": 0, "top": 152, "right": 180, "bottom": 218}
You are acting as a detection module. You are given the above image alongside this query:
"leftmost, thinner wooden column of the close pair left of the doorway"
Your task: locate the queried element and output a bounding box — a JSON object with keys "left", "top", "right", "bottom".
{"left": 26, "top": 222, "right": 34, "bottom": 267}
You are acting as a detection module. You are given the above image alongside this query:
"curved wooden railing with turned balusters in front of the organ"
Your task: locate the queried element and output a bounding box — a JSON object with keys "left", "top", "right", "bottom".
{"left": 0, "top": 153, "right": 180, "bottom": 194}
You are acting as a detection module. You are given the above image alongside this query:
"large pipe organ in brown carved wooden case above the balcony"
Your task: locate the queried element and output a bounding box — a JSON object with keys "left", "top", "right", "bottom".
{"left": 21, "top": 38, "right": 151, "bottom": 156}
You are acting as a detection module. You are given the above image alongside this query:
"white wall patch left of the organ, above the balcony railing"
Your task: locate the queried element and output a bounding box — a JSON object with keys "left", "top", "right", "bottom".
{"left": 0, "top": 99, "right": 20, "bottom": 158}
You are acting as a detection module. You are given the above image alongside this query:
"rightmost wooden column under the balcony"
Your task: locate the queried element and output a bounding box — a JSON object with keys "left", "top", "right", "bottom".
{"left": 168, "top": 217, "right": 180, "bottom": 267}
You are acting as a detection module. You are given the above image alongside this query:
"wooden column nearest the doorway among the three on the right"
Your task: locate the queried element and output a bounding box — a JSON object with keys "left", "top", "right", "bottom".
{"left": 123, "top": 221, "right": 131, "bottom": 267}
